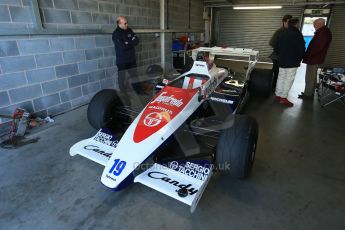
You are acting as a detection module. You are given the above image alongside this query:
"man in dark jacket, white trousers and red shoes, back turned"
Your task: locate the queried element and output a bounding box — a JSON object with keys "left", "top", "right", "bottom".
{"left": 274, "top": 18, "right": 305, "bottom": 107}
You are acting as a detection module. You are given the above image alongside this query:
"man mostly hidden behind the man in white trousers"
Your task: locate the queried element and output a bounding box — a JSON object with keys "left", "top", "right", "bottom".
{"left": 269, "top": 14, "right": 292, "bottom": 90}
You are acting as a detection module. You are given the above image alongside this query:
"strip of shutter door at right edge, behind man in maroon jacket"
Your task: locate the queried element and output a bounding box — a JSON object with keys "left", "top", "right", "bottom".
{"left": 325, "top": 5, "right": 345, "bottom": 67}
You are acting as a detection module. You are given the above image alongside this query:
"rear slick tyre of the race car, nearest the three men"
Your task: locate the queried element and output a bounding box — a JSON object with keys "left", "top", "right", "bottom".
{"left": 249, "top": 69, "right": 273, "bottom": 97}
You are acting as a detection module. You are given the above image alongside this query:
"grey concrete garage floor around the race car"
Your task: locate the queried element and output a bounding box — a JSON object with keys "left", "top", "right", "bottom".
{"left": 0, "top": 64, "right": 345, "bottom": 230}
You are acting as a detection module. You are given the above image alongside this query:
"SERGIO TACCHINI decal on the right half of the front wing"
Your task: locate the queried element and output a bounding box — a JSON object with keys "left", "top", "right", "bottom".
{"left": 168, "top": 161, "right": 210, "bottom": 181}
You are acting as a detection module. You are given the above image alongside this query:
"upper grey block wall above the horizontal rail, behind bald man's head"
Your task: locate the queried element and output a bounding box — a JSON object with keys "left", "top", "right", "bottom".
{"left": 0, "top": 0, "right": 159, "bottom": 29}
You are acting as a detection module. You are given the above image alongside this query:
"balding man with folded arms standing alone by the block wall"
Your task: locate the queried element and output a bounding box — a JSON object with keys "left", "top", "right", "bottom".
{"left": 112, "top": 16, "right": 142, "bottom": 93}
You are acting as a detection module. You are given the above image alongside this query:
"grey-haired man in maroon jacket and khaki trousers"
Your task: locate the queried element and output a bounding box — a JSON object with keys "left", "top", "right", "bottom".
{"left": 298, "top": 18, "right": 332, "bottom": 99}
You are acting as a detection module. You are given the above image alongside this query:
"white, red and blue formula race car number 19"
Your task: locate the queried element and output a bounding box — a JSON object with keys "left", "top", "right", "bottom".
{"left": 70, "top": 47, "right": 272, "bottom": 212}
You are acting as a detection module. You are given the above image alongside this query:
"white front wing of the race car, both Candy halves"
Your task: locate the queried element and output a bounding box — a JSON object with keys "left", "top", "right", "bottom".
{"left": 70, "top": 129, "right": 212, "bottom": 212}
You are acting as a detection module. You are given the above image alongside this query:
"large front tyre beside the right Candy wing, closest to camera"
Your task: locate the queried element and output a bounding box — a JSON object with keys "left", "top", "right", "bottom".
{"left": 215, "top": 115, "right": 258, "bottom": 179}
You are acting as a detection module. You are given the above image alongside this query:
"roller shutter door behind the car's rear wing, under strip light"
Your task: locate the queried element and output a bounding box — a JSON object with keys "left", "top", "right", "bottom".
{"left": 213, "top": 6, "right": 303, "bottom": 61}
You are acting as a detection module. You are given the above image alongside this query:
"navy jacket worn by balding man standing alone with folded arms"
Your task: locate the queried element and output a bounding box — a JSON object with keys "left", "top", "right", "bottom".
{"left": 112, "top": 27, "right": 139, "bottom": 65}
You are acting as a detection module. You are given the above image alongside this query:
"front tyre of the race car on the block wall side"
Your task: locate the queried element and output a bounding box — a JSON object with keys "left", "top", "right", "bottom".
{"left": 87, "top": 89, "right": 128, "bottom": 130}
